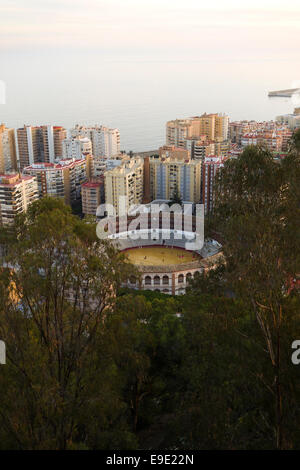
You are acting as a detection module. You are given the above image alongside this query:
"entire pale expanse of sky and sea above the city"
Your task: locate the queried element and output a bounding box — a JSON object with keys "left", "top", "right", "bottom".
{"left": 0, "top": 0, "right": 300, "bottom": 151}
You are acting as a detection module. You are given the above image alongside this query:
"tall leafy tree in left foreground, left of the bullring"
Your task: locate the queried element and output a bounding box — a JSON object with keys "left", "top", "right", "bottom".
{"left": 0, "top": 198, "right": 135, "bottom": 449}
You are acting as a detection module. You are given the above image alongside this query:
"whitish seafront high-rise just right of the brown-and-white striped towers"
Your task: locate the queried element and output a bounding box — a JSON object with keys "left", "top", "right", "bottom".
{"left": 71, "top": 125, "right": 120, "bottom": 158}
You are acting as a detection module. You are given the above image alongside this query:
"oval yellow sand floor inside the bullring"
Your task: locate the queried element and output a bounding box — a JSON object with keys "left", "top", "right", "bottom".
{"left": 125, "top": 246, "right": 201, "bottom": 266}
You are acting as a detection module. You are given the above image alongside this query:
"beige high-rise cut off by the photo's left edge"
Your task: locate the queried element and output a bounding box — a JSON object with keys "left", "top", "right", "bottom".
{"left": 0, "top": 124, "right": 17, "bottom": 173}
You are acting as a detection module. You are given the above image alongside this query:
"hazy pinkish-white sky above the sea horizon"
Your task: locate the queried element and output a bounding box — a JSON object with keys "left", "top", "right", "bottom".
{"left": 0, "top": 0, "right": 300, "bottom": 60}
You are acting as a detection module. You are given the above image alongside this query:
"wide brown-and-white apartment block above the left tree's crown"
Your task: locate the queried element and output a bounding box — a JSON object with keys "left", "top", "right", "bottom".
{"left": 23, "top": 158, "right": 88, "bottom": 204}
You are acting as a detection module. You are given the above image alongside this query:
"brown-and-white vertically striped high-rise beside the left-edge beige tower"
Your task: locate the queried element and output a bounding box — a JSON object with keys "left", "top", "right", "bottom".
{"left": 15, "top": 126, "right": 66, "bottom": 170}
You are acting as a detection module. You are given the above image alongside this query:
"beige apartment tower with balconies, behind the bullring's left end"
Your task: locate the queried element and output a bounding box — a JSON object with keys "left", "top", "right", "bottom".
{"left": 104, "top": 157, "right": 144, "bottom": 215}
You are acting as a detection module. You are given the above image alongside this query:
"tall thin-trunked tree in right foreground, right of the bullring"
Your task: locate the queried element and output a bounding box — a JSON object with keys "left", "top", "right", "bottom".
{"left": 214, "top": 140, "right": 300, "bottom": 449}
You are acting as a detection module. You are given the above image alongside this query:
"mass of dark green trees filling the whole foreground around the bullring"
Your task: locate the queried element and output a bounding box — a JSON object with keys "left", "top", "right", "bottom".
{"left": 0, "top": 142, "right": 300, "bottom": 456}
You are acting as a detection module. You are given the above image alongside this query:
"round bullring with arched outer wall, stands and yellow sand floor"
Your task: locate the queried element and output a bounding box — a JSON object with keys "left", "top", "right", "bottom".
{"left": 104, "top": 213, "right": 222, "bottom": 295}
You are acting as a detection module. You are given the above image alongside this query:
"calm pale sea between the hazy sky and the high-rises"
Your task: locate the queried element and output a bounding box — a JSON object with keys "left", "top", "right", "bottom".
{"left": 0, "top": 50, "right": 300, "bottom": 152}
